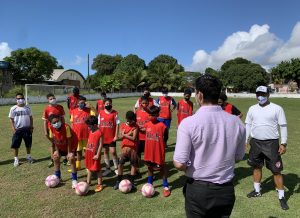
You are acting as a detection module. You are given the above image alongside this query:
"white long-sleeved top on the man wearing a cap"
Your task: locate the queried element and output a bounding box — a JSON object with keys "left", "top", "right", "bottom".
{"left": 245, "top": 103, "right": 287, "bottom": 143}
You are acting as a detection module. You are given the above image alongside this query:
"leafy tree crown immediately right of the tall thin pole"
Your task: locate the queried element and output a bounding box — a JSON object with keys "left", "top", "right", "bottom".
{"left": 92, "top": 54, "right": 123, "bottom": 76}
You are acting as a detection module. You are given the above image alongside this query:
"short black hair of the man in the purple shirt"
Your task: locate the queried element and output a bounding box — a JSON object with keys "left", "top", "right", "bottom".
{"left": 195, "top": 75, "right": 222, "bottom": 104}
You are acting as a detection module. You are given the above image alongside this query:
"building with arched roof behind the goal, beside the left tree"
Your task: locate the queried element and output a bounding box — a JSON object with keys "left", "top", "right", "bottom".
{"left": 48, "top": 69, "right": 85, "bottom": 88}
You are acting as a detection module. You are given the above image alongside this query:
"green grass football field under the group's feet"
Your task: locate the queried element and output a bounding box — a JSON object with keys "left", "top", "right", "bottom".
{"left": 0, "top": 98, "right": 300, "bottom": 218}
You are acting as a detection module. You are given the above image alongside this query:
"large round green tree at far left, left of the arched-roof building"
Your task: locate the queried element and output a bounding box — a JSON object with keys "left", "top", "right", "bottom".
{"left": 4, "top": 47, "right": 58, "bottom": 83}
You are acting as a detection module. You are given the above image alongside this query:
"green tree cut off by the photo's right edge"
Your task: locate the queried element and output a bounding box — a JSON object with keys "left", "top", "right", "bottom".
{"left": 271, "top": 58, "right": 300, "bottom": 88}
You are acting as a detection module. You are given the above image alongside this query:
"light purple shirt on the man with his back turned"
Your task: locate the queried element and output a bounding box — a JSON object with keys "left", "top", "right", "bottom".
{"left": 173, "top": 105, "right": 246, "bottom": 184}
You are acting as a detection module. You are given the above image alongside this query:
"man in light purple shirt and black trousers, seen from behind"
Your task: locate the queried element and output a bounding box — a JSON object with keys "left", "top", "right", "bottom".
{"left": 173, "top": 75, "right": 246, "bottom": 217}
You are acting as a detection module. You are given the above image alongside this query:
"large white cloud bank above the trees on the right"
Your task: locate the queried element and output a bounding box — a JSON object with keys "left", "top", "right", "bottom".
{"left": 187, "top": 22, "right": 300, "bottom": 72}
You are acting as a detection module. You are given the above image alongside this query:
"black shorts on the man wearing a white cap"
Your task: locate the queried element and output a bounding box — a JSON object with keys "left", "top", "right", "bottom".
{"left": 248, "top": 138, "right": 283, "bottom": 173}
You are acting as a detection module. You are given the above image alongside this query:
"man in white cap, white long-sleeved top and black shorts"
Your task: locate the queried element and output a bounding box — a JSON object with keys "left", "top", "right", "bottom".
{"left": 245, "top": 86, "right": 289, "bottom": 210}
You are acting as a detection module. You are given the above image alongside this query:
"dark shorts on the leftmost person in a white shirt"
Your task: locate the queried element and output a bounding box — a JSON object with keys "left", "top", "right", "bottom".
{"left": 11, "top": 128, "right": 32, "bottom": 149}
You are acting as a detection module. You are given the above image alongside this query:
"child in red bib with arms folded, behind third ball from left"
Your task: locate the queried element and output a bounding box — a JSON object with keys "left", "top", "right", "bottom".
{"left": 114, "top": 111, "right": 138, "bottom": 190}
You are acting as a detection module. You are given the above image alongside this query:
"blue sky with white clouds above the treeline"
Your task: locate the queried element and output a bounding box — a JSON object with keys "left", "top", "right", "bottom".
{"left": 0, "top": 0, "right": 300, "bottom": 75}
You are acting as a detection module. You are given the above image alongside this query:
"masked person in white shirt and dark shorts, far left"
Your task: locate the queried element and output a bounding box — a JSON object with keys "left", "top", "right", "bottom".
{"left": 8, "top": 93, "right": 33, "bottom": 167}
